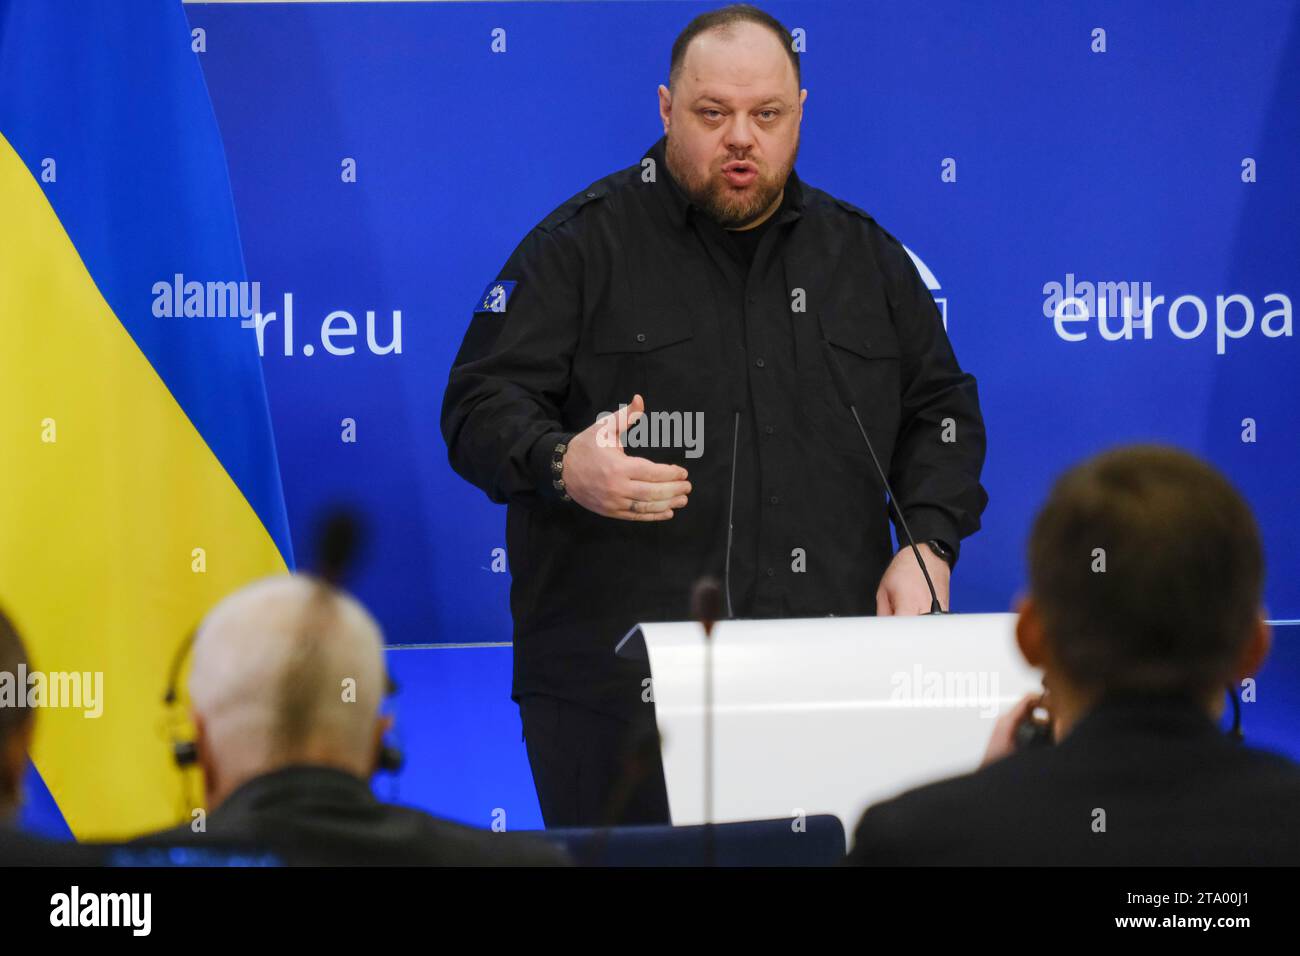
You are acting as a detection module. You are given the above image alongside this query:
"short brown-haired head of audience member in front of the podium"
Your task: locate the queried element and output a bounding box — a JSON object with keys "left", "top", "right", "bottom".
{"left": 1017, "top": 445, "right": 1270, "bottom": 734}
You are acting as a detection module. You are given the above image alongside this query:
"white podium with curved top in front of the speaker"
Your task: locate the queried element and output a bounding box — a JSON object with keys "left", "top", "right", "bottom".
{"left": 618, "top": 614, "right": 1040, "bottom": 842}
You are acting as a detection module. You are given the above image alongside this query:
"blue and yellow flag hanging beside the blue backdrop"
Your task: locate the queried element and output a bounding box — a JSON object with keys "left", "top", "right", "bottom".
{"left": 0, "top": 0, "right": 293, "bottom": 839}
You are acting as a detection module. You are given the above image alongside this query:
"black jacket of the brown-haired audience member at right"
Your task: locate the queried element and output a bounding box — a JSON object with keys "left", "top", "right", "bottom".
{"left": 848, "top": 697, "right": 1300, "bottom": 866}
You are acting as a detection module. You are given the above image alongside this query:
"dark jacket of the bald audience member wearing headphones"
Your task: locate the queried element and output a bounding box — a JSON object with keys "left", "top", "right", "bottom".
{"left": 133, "top": 766, "right": 568, "bottom": 866}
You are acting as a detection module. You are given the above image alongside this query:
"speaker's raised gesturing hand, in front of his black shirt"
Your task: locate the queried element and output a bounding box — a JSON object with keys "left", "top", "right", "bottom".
{"left": 562, "top": 395, "right": 690, "bottom": 522}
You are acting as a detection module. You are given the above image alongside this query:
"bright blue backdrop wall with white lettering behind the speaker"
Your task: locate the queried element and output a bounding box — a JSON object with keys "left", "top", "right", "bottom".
{"left": 167, "top": 0, "right": 1300, "bottom": 826}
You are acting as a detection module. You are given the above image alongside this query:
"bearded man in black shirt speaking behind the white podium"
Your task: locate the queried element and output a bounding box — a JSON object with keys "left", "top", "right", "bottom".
{"left": 442, "top": 7, "right": 987, "bottom": 826}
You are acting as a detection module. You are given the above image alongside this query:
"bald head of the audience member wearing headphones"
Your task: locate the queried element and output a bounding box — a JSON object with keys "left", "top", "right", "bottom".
{"left": 189, "top": 575, "right": 390, "bottom": 809}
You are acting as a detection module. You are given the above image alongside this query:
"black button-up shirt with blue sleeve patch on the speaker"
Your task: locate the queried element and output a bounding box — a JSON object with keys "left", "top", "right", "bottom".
{"left": 442, "top": 139, "right": 988, "bottom": 714}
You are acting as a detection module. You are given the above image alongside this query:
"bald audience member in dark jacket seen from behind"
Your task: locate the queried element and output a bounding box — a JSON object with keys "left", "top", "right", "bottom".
{"left": 139, "top": 575, "right": 566, "bottom": 866}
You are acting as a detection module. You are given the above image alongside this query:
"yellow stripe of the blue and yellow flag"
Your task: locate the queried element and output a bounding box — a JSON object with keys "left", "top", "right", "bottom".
{"left": 0, "top": 137, "right": 285, "bottom": 839}
